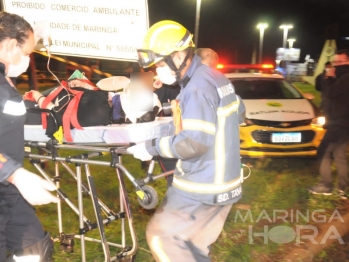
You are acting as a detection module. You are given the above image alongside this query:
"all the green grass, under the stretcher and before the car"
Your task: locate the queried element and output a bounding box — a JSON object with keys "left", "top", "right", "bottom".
{"left": 21, "top": 83, "right": 342, "bottom": 262}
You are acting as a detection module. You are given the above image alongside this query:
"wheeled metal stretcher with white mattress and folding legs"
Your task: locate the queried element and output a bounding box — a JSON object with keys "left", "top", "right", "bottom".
{"left": 24, "top": 115, "right": 173, "bottom": 262}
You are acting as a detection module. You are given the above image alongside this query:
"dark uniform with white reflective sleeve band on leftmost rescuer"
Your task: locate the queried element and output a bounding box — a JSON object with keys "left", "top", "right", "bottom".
{"left": 0, "top": 63, "right": 51, "bottom": 262}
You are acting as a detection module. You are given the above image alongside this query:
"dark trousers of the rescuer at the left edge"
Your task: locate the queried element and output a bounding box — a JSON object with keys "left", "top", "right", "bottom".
{"left": 0, "top": 184, "right": 45, "bottom": 262}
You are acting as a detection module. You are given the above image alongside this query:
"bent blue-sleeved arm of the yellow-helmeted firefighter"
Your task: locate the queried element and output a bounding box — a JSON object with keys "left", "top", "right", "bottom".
{"left": 146, "top": 88, "right": 218, "bottom": 160}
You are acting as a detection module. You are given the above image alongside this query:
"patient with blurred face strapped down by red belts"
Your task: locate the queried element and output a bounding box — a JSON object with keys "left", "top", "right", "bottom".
{"left": 23, "top": 72, "right": 162, "bottom": 140}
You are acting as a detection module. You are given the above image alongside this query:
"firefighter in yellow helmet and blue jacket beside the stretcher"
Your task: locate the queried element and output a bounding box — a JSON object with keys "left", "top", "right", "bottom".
{"left": 128, "top": 20, "right": 245, "bottom": 261}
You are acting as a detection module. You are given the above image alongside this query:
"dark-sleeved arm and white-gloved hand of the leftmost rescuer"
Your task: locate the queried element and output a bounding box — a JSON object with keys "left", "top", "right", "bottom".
{"left": 0, "top": 88, "right": 58, "bottom": 205}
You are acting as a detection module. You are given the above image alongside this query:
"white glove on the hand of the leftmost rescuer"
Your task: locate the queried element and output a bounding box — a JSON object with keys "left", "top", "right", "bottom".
{"left": 11, "top": 168, "right": 58, "bottom": 205}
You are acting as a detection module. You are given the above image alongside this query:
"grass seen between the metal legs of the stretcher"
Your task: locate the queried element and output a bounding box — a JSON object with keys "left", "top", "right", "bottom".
{"left": 26, "top": 156, "right": 162, "bottom": 261}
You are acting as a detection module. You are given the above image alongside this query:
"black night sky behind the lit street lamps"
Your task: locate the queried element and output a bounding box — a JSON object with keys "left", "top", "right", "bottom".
{"left": 148, "top": 0, "right": 349, "bottom": 63}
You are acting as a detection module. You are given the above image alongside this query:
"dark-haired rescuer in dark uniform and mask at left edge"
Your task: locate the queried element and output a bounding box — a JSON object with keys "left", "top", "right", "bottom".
{"left": 0, "top": 12, "right": 57, "bottom": 262}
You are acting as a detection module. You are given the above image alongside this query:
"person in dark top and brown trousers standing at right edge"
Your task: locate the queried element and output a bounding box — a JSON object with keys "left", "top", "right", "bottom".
{"left": 309, "top": 50, "right": 349, "bottom": 199}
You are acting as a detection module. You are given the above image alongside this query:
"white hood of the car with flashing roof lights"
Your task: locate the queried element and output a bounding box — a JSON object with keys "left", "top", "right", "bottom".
{"left": 243, "top": 99, "right": 315, "bottom": 121}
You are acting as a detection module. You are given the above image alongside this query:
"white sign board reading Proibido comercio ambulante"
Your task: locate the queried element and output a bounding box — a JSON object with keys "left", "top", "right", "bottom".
{"left": 3, "top": 0, "right": 149, "bottom": 61}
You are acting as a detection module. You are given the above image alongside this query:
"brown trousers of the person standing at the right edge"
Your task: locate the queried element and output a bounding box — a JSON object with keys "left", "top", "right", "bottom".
{"left": 318, "top": 127, "right": 349, "bottom": 190}
